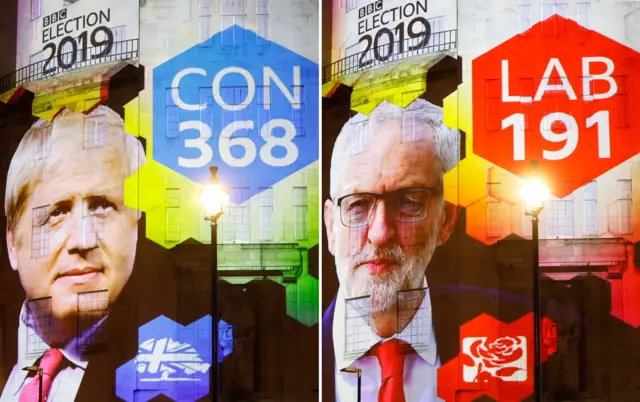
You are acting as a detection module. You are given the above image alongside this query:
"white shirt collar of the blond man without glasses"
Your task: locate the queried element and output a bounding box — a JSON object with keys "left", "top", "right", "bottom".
{"left": 18, "top": 302, "right": 107, "bottom": 370}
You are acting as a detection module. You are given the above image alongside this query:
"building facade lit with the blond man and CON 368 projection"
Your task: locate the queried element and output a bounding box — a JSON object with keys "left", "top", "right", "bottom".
{"left": 0, "top": 0, "right": 319, "bottom": 401}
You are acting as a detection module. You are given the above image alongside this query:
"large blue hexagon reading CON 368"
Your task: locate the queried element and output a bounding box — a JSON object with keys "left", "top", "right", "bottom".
{"left": 153, "top": 25, "right": 319, "bottom": 203}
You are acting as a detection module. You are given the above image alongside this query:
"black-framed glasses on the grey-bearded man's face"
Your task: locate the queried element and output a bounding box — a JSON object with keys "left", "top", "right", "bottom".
{"left": 336, "top": 187, "right": 442, "bottom": 228}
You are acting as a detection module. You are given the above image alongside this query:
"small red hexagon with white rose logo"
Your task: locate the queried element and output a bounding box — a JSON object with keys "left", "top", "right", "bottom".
{"left": 438, "top": 313, "right": 557, "bottom": 402}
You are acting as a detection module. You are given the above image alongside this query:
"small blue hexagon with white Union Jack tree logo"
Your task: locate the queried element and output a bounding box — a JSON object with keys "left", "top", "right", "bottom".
{"left": 116, "top": 315, "right": 233, "bottom": 402}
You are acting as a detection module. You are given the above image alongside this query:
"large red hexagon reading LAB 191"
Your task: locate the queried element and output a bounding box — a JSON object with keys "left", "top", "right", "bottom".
{"left": 472, "top": 15, "right": 640, "bottom": 197}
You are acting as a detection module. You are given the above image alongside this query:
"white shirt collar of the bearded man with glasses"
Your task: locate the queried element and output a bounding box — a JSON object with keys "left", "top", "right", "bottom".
{"left": 332, "top": 278, "right": 437, "bottom": 370}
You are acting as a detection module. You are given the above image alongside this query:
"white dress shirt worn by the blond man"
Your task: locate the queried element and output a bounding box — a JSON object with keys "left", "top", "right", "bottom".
{"left": 0, "top": 304, "right": 106, "bottom": 402}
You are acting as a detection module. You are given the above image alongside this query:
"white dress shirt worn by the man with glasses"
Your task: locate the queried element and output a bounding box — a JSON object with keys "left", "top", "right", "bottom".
{"left": 333, "top": 279, "right": 443, "bottom": 402}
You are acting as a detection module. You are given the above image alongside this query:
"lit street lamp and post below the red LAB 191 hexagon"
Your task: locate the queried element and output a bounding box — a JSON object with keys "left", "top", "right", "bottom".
{"left": 520, "top": 178, "right": 550, "bottom": 402}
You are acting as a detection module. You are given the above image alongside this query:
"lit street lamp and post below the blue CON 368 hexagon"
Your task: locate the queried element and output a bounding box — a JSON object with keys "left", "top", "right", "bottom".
{"left": 198, "top": 166, "right": 229, "bottom": 401}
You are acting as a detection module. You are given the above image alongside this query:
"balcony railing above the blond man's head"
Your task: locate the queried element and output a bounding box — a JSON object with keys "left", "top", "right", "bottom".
{"left": 0, "top": 39, "right": 139, "bottom": 93}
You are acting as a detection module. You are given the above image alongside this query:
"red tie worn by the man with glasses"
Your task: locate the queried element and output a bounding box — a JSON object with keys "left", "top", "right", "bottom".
{"left": 371, "top": 339, "right": 408, "bottom": 402}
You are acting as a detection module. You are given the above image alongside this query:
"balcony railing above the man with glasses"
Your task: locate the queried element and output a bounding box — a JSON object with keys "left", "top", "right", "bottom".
{"left": 322, "top": 29, "right": 458, "bottom": 83}
